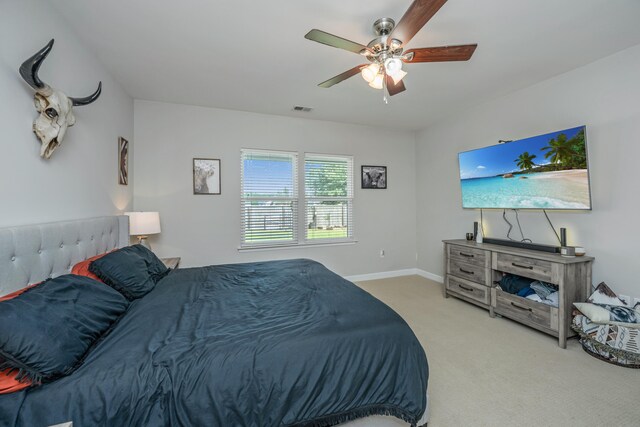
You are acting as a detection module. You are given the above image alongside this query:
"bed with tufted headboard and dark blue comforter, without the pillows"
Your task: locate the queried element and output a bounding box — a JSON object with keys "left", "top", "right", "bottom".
{"left": 0, "top": 217, "right": 428, "bottom": 426}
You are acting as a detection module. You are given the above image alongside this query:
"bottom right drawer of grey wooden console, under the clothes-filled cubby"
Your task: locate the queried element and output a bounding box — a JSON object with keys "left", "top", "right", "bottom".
{"left": 492, "top": 288, "right": 558, "bottom": 331}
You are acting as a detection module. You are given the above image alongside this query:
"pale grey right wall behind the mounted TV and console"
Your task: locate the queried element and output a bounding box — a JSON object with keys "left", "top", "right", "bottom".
{"left": 416, "top": 46, "right": 640, "bottom": 297}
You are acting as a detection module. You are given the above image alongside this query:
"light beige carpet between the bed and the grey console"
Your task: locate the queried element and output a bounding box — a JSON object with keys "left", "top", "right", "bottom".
{"left": 357, "top": 276, "right": 640, "bottom": 427}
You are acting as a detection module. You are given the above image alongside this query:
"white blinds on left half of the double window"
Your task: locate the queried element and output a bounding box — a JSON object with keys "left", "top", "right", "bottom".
{"left": 240, "top": 150, "right": 298, "bottom": 246}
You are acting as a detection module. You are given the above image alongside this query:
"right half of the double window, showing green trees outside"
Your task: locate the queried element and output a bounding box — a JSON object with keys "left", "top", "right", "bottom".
{"left": 304, "top": 154, "right": 353, "bottom": 241}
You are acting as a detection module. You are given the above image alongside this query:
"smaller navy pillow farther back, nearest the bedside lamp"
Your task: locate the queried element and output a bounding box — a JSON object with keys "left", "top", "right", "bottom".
{"left": 89, "top": 245, "right": 169, "bottom": 301}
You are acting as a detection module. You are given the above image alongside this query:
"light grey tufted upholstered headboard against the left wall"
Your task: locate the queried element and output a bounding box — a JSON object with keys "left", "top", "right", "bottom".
{"left": 0, "top": 215, "right": 129, "bottom": 296}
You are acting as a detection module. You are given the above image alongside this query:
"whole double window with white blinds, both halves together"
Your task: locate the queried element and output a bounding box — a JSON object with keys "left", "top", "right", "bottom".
{"left": 240, "top": 149, "right": 353, "bottom": 247}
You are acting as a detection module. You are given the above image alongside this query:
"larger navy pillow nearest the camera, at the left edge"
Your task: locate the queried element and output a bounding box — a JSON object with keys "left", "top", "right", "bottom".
{"left": 0, "top": 274, "right": 129, "bottom": 384}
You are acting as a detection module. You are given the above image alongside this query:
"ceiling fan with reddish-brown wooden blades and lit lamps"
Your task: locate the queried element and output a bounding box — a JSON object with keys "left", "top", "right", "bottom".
{"left": 304, "top": 0, "right": 478, "bottom": 102}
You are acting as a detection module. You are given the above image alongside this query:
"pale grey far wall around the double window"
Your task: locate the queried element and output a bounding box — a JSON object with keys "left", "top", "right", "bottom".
{"left": 134, "top": 100, "right": 416, "bottom": 275}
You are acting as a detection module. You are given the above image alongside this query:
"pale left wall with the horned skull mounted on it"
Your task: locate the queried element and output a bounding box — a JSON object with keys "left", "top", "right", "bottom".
{"left": 0, "top": 0, "right": 133, "bottom": 227}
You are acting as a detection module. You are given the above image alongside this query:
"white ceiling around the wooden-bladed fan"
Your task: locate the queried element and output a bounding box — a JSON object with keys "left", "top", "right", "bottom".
{"left": 51, "top": 0, "right": 640, "bottom": 130}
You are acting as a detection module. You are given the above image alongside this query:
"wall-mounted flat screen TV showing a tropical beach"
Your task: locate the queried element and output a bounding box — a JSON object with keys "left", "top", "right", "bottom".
{"left": 458, "top": 126, "right": 591, "bottom": 210}
